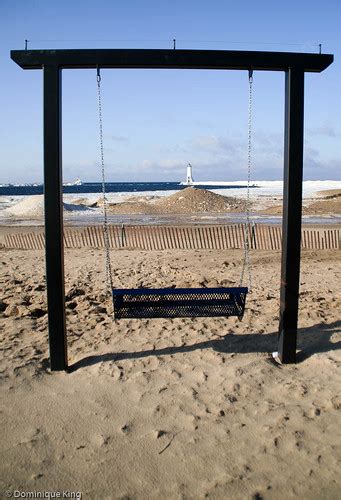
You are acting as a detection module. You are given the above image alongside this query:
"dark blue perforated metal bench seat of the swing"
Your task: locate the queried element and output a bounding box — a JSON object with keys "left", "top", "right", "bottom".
{"left": 112, "top": 287, "right": 248, "bottom": 319}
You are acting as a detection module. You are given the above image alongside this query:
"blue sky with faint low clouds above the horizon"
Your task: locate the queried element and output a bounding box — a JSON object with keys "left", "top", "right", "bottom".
{"left": 0, "top": 0, "right": 341, "bottom": 184}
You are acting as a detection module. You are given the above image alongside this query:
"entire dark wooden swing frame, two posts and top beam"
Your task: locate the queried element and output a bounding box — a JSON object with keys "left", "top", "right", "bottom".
{"left": 11, "top": 49, "right": 334, "bottom": 371}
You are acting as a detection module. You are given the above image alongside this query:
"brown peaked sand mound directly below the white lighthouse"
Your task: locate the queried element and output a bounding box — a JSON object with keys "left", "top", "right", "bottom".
{"left": 109, "top": 187, "right": 244, "bottom": 214}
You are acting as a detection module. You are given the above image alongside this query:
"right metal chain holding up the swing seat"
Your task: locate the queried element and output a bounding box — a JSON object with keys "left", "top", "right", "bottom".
{"left": 240, "top": 70, "right": 253, "bottom": 291}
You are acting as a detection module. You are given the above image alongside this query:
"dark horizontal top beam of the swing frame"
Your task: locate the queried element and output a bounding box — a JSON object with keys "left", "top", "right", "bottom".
{"left": 11, "top": 49, "right": 333, "bottom": 73}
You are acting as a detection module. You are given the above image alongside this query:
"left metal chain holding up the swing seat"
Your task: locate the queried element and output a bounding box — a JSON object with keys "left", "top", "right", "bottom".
{"left": 97, "top": 68, "right": 113, "bottom": 293}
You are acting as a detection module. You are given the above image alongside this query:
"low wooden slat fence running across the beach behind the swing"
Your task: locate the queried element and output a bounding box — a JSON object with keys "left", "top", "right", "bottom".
{"left": 4, "top": 224, "right": 341, "bottom": 250}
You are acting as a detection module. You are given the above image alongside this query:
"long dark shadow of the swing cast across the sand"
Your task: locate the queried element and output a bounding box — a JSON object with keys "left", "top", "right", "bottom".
{"left": 69, "top": 321, "right": 341, "bottom": 372}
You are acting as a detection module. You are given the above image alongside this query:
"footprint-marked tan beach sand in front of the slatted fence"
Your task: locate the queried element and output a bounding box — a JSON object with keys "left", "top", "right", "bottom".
{"left": 0, "top": 244, "right": 341, "bottom": 500}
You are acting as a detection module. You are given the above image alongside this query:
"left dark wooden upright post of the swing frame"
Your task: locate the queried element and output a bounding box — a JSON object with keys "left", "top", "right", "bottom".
{"left": 44, "top": 65, "right": 67, "bottom": 371}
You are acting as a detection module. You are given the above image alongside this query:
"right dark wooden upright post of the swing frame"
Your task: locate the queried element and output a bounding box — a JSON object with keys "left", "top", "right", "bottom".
{"left": 278, "top": 67, "right": 304, "bottom": 363}
